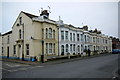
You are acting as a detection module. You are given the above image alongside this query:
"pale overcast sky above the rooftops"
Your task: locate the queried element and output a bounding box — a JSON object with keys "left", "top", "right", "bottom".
{"left": 0, "top": 1, "right": 118, "bottom": 37}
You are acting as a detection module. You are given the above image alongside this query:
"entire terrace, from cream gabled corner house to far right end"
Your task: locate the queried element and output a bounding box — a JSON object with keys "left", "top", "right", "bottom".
{"left": 0, "top": 10, "right": 112, "bottom": 61}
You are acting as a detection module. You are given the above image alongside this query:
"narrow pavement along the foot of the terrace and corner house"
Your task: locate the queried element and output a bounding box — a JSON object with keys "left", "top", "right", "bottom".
{"left": 1, "top": 53, "right": 112, "bottom": 65}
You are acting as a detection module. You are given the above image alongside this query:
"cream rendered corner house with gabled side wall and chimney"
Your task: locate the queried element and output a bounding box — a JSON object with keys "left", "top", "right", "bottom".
{"left": 2, "top": 10, "right": 58, "bottom": 60}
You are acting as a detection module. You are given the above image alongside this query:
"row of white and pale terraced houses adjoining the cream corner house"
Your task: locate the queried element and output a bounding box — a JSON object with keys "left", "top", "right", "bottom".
{"left": 59, "top": 20, "right": 112, "bottom": 55}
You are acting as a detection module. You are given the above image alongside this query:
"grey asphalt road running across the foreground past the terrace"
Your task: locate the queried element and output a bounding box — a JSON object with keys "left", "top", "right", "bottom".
{"left": 3, "top": 54, "right": 118, "bottom": 78}
